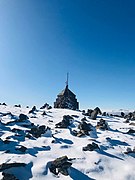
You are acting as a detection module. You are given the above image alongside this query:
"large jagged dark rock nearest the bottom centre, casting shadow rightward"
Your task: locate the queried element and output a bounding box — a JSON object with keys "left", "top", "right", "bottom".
{"left": 49, "top": 156, "right": 72, "bottom": 176}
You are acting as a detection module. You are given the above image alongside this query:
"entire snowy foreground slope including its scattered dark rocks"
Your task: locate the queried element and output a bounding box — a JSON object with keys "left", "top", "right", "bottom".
{"left": 0, "top": 104, "right": 135, "bottom": 180}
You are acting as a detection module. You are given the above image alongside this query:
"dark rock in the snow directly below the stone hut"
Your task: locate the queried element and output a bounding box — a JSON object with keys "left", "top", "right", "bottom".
{"left": 55, "top": 115, "right": 74, "bottom": 128}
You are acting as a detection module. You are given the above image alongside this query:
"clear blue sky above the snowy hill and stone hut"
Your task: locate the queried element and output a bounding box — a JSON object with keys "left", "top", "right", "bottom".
{"left": 0, "top": 0, "right": 135, "bottom": 109}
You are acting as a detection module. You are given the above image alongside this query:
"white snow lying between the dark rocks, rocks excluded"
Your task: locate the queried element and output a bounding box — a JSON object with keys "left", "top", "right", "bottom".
{"left": 0, "top": 105, "right": 135, "bottom": 180}
